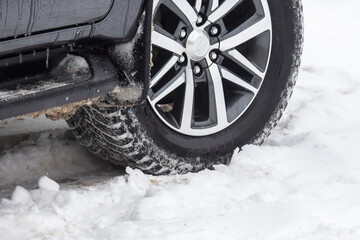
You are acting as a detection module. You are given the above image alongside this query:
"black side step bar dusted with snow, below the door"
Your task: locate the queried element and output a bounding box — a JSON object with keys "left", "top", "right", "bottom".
{"left": 0, "top": 53, "right": 120, "bottom": 120}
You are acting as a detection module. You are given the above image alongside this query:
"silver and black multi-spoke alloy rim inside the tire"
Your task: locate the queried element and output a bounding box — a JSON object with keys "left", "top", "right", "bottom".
{"left": 148, "top": 0, "right": 272, "bottom": 136}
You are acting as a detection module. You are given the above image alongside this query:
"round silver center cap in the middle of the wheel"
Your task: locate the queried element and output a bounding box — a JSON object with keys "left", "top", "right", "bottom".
{"left": 186, "top": 30, "right": 210, "bottom": 61}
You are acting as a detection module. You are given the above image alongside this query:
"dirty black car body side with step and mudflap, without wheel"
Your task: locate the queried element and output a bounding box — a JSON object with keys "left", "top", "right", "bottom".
{"left": 0, "top": 0, "right": 152, "bottom": 119}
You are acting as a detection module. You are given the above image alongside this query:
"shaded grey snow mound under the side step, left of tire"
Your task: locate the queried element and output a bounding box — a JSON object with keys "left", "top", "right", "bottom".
{"left": 0, "top": 130, "right": 110, "bottom": 186}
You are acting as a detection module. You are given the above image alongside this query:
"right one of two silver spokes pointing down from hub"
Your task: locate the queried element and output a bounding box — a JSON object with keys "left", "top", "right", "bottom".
{"left": 209, "top": 64, "right": 228, "bottom": 126}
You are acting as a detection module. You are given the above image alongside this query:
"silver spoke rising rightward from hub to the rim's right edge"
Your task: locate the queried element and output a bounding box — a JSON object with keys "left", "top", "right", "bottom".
{"left": 220, "top": 16, "right": 271, "bottom": 51}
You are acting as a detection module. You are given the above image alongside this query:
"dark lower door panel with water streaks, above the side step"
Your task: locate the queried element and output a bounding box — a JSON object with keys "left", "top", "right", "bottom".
{"left": 0, "top": 0, "right": 113, "bottom": 39}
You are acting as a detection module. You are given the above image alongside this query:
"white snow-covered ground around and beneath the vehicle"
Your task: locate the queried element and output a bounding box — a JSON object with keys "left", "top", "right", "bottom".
{"left": 0, "top": 0, "right": 360, "bottom": 240}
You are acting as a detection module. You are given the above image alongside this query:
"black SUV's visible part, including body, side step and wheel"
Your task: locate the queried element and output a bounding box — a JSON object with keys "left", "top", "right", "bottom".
{"left": 0, "top": 0, "right": 303, "bottom": 175}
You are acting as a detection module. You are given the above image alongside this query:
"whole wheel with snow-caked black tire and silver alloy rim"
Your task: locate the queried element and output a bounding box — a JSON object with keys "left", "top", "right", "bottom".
{"left": 68, "top": 0, "right": 303, "bottom": 175}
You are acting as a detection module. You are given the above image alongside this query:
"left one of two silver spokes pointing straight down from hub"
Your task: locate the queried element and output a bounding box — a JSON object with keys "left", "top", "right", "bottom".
{"left": 181, "top": 66, "right": 194, "bottom": 130}
